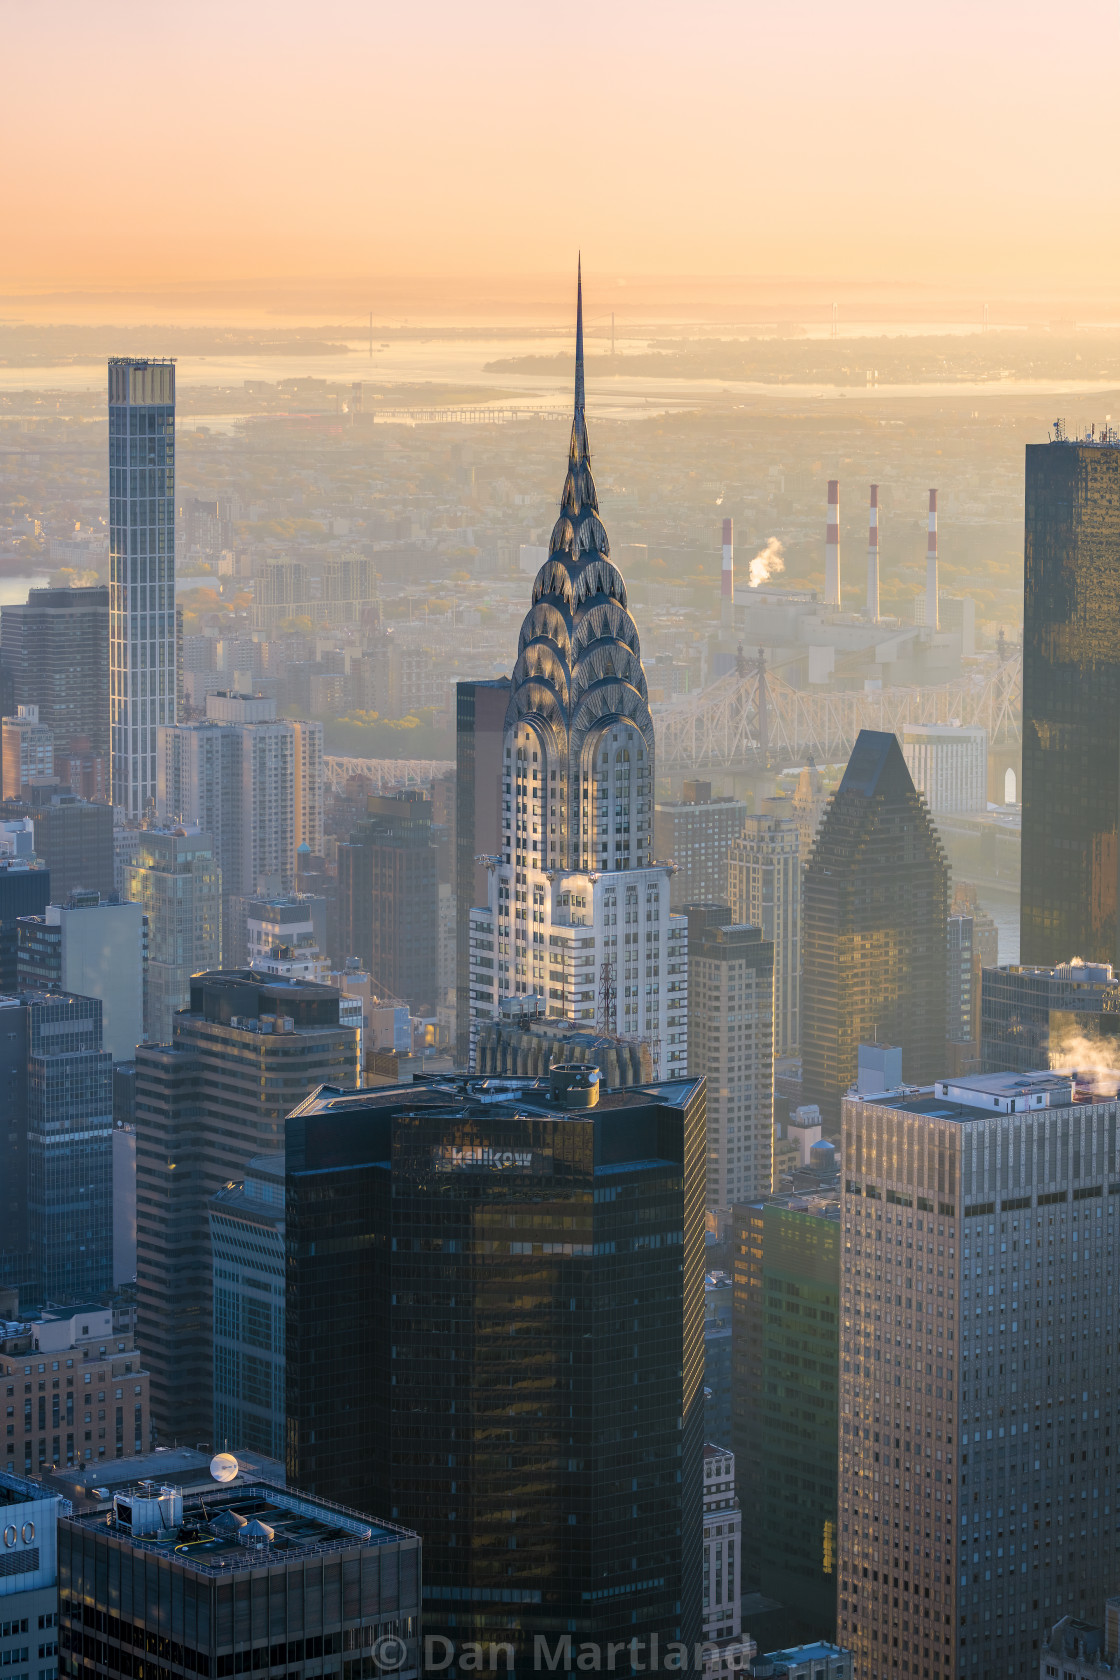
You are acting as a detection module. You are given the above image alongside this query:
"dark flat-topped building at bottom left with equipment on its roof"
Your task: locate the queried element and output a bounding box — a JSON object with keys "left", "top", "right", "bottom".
{"left": 59, "top": 1482, "right": 420, "bottom": 1680}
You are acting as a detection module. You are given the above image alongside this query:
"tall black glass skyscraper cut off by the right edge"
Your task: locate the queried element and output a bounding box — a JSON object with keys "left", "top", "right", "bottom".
{"left": 1021, "top": 433, "right": 1120, "bottom": 968}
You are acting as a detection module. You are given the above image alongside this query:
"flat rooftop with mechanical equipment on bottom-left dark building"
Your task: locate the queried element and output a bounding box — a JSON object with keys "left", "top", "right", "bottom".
{"left": 71, "top": 1482, "right": 416, "bottom": 1574}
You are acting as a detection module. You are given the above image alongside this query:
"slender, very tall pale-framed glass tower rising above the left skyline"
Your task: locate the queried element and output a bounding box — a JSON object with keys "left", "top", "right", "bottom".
{"left": 109, "top": 356, "right": 178, "bottom": 816}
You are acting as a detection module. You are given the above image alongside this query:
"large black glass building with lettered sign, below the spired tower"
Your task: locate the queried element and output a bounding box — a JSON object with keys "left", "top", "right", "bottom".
{"left": 287, "top": 1080, "right": 704, "bottom": 1673}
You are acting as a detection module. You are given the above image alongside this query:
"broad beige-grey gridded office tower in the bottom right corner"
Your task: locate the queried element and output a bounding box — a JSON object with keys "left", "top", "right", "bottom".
{"left": 838, "top": 1074, "right": 1120, "bottom": 1680}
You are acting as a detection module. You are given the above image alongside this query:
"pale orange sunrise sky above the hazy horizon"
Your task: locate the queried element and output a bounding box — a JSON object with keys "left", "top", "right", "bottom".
{"left": 8, "top": 0, "right": 1120, "bottom": 294}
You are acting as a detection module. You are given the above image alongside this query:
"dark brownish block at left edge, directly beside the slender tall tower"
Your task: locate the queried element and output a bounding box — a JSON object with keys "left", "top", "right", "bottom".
{"left": 0, "top": 583, "right": 109, "bottom": 761}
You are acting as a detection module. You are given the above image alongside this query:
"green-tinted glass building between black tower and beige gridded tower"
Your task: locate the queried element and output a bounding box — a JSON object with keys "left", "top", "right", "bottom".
{"left": 732, "top": 1196, "right": 840, "bottom": 1641}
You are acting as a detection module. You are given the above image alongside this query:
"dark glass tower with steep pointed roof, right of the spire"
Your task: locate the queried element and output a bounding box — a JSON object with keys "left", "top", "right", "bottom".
{"left": 801, "top": 729, "right": 949, "bottom": 1131}
